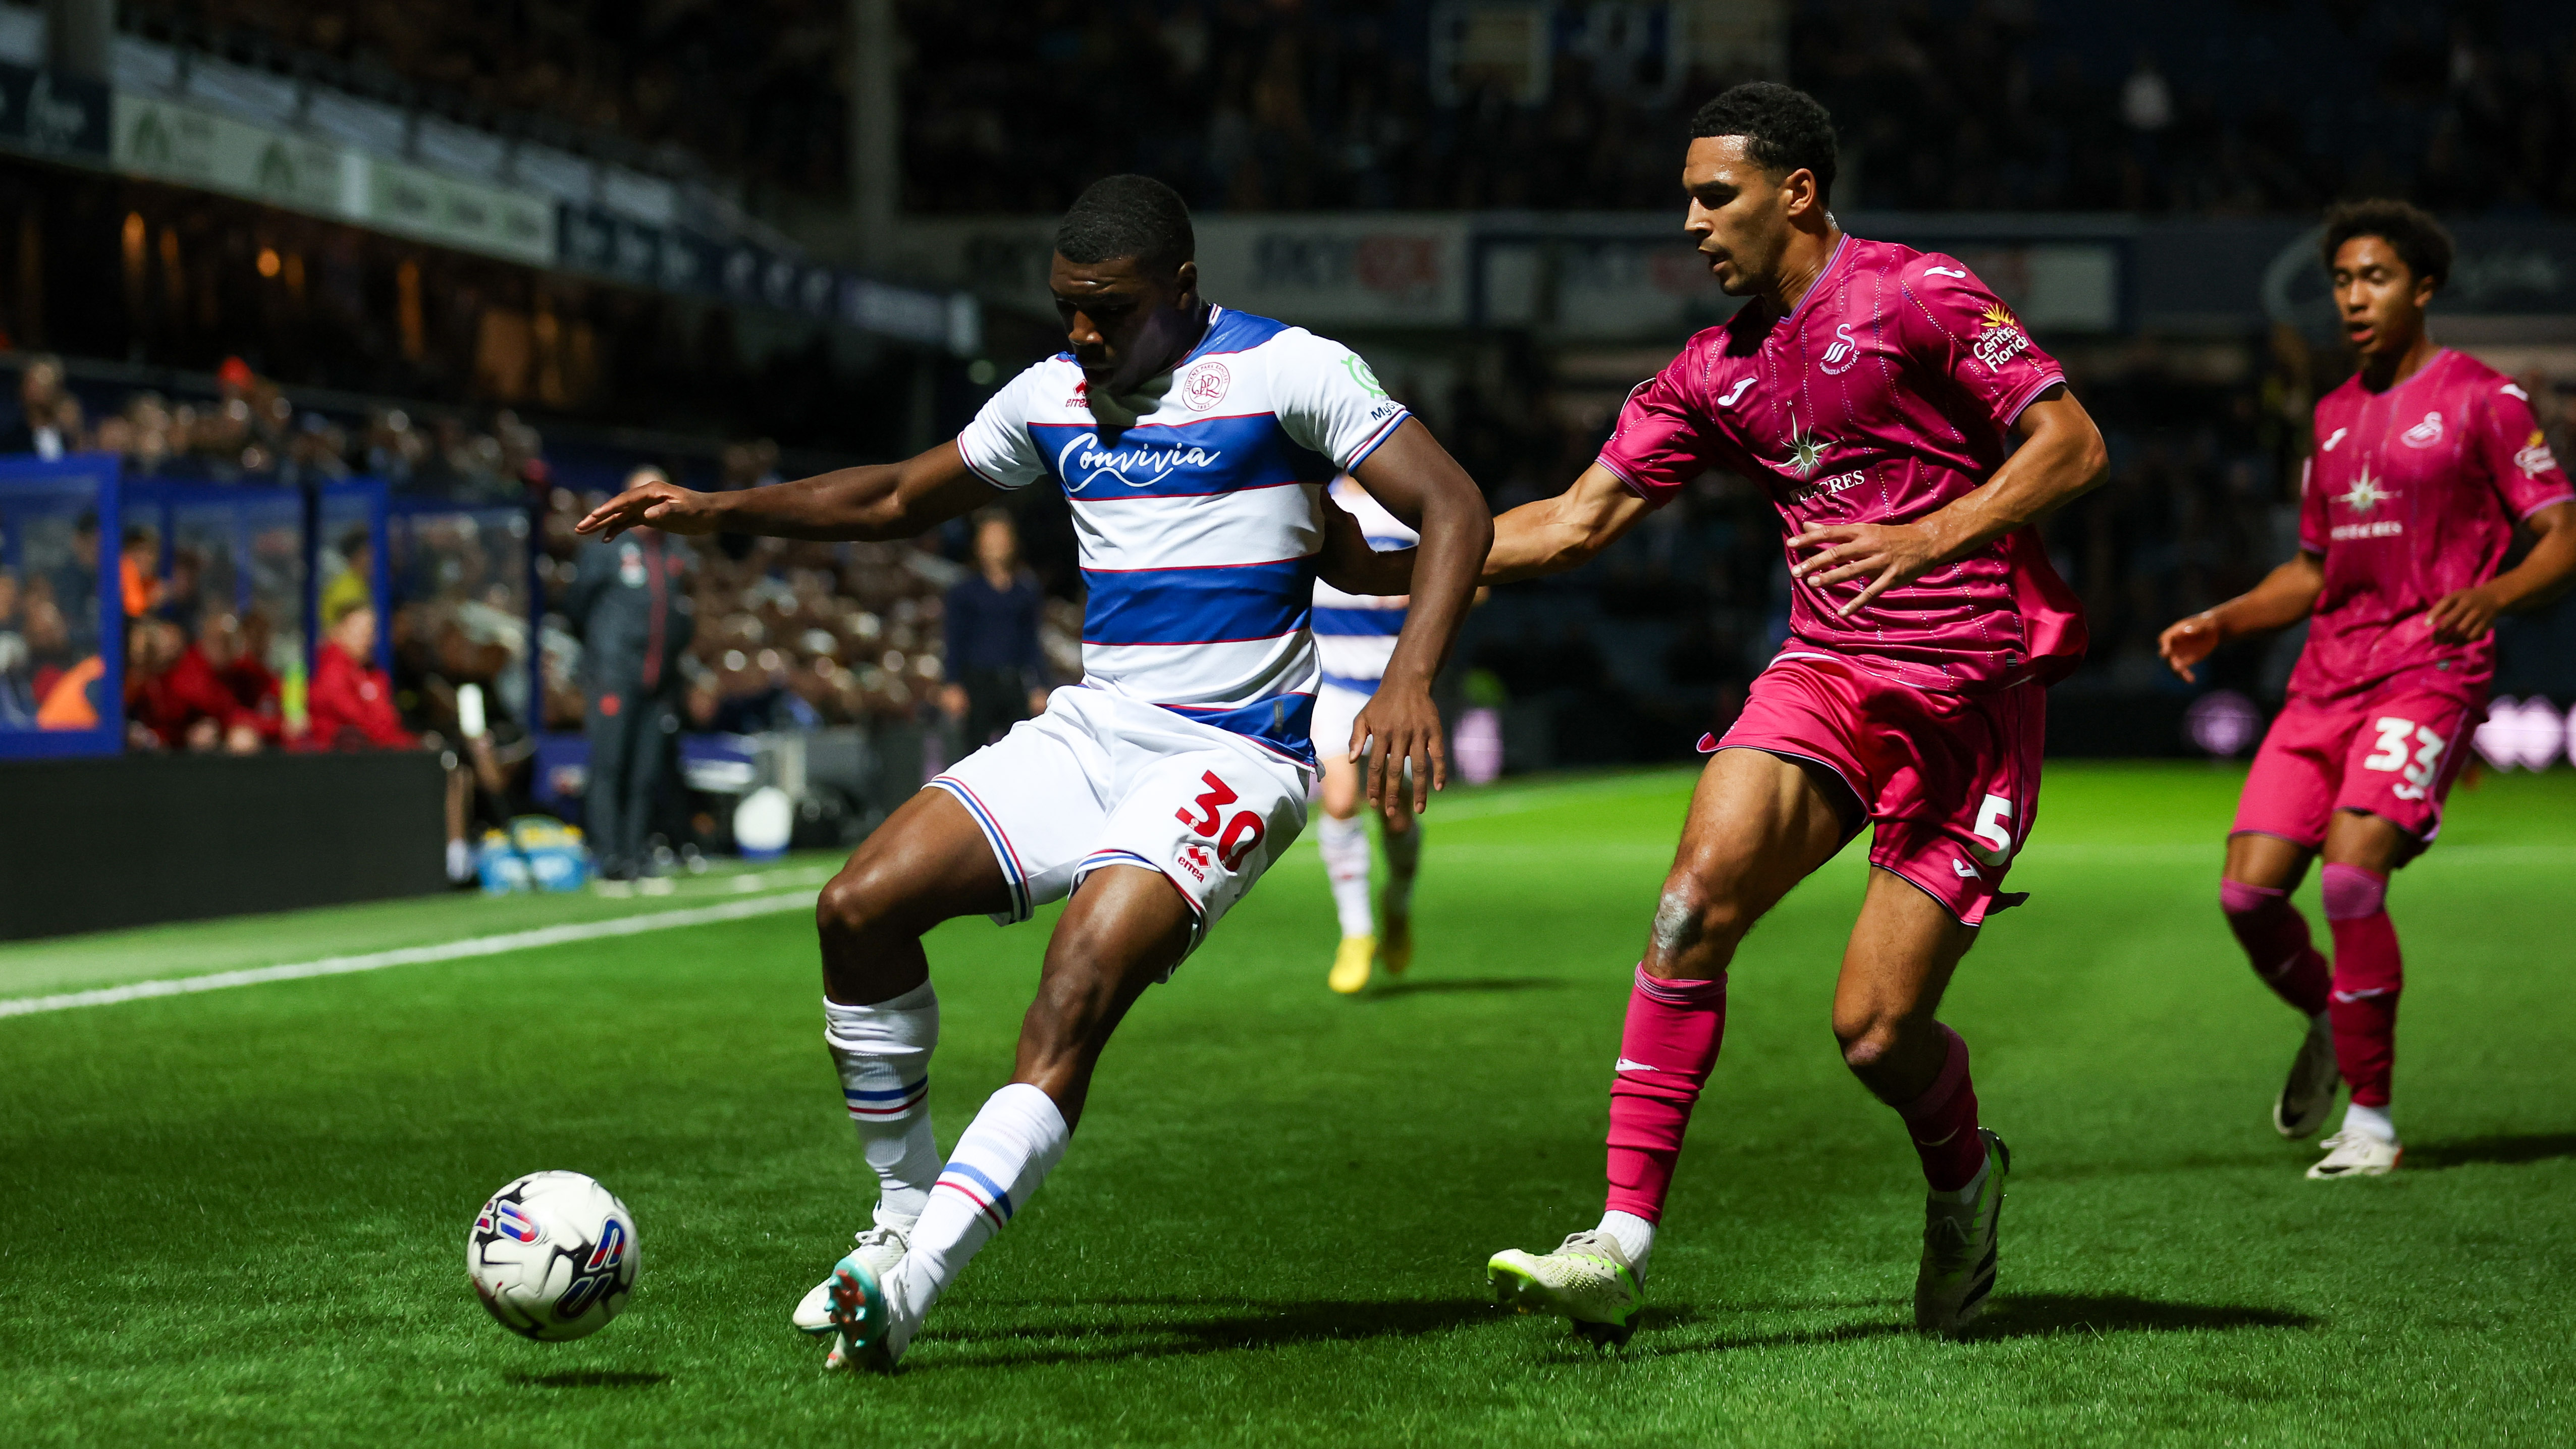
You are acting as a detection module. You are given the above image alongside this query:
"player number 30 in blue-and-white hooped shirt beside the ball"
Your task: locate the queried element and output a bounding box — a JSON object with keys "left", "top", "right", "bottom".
{"left": 579, "top": 175, "right": 1491, "bottom": 1369}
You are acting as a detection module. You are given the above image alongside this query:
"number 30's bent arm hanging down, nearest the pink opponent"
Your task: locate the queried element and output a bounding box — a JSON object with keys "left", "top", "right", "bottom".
{"left": 1350, "top": 418, "right": 1494, "bottom": 815}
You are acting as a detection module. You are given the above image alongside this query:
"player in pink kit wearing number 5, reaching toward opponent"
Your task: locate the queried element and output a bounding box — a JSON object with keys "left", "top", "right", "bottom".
{"left": 1484, "top": 82, "right": 2102, "bottom": 1344}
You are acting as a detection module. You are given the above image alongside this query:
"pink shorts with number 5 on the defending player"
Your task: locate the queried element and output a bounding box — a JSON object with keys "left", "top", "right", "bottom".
{"left": 1703, "top": 645, "right": 2048, "bottom": 926}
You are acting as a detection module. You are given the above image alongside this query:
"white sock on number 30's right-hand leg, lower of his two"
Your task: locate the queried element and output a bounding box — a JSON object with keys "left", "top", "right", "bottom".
{"left": 889, "top": 1083, "right": 1071, "bottom": 1354}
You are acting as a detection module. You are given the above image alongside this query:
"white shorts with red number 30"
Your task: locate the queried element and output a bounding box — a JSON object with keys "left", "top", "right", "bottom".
{"left": 930, "top": 686, "right": 1308, "bottom": 951}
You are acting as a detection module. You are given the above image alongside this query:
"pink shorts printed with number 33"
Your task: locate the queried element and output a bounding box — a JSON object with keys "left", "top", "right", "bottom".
{"left": 2231, "top": 688, "right": 2486, "bottom": 858}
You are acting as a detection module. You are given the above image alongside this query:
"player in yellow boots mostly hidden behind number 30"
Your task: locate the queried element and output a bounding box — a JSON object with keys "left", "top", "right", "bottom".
{"left": 1314, "top": 474, "right": 1422, "bottom": 995}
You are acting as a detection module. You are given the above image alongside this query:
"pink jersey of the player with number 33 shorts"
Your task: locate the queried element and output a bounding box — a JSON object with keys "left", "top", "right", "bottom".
{"left": 2290, "top": 348, "right": 2576, "bottom": 699}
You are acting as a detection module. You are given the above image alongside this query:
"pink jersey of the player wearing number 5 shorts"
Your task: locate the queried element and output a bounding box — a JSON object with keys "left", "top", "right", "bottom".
{"left": 1600, "top": 237, "right": 2084, "bottom": 688}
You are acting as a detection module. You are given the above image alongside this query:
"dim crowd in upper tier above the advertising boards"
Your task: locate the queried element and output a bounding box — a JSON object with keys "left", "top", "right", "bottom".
{"left": 116, "top": 0, "right": 2576, "bottom": 223}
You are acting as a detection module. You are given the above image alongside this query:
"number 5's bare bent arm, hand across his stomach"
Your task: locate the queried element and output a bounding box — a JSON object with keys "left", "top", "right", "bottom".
{"left": 1788, "top": 387, "right": 2110, "bottom": 616}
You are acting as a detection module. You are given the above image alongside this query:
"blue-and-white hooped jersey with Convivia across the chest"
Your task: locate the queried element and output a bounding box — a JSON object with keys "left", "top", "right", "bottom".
{"left": 958, "top": 307, "right": 1409, "bottom": 766}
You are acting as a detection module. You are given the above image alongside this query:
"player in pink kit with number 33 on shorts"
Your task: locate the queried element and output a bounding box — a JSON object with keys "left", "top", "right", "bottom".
{"left": 2161, "top": 201, "right": 2576, "bottom": 1178}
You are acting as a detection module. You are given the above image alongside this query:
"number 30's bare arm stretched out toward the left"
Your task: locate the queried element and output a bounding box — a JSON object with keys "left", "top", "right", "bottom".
{"left": 574, "top": 441, "right": 994, "bottom": 542}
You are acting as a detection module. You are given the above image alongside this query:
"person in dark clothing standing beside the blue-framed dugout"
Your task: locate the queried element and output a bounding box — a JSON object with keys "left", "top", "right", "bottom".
{"left": 564, "top": 469, "right": 698, "bottom": 895}
